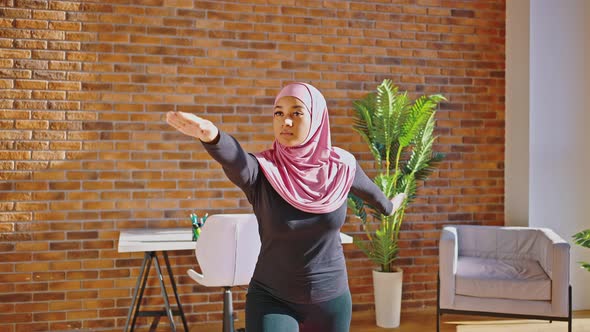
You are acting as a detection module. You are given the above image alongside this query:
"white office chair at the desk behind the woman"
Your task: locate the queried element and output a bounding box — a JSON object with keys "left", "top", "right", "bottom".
{"left": 188, "top": 214, "right": 260, "bottom": 332}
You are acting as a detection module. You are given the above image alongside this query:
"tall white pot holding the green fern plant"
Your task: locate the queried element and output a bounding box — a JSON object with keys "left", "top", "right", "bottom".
{"left": 373, "top": 270, "right": 403, "bottom": 328}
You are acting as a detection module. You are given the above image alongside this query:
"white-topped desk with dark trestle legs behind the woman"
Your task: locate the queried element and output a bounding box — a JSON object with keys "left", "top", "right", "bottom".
{"left": 118, "top": 227, "right": 352, "bottom": 332}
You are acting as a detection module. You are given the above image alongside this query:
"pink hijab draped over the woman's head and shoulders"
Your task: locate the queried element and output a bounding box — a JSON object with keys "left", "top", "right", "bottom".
{"left": 256, "top": 83, "right": 356, "bottom": 214}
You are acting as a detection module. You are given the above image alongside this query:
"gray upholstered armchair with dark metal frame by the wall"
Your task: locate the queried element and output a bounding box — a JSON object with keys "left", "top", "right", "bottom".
{"left": 437, "top": 225, "right": 572, "bottom": 332}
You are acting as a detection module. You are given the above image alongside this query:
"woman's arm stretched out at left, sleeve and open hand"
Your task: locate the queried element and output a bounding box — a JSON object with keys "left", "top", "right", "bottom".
{"left": 166, "top": 112, "right": 258, "bottom": 190}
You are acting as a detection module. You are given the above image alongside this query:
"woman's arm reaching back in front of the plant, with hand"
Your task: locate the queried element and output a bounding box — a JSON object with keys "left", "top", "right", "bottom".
{"left": 350, "top": 163, "right": 406, "bottom": 215}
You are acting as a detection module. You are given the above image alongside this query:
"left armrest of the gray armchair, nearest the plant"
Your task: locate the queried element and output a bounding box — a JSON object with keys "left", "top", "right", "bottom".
{"left": 438, "top": 226, "right": 459, "bottom": 308}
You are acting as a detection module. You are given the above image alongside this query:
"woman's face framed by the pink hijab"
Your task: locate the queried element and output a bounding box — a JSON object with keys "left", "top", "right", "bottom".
{"left": 272, "top": 96, "right": 311, "bottom": 147}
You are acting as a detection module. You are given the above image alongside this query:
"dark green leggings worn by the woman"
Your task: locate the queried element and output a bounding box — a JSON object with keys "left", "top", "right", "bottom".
{"left": 246, "top": 282, "right": 352, "bottom": 332}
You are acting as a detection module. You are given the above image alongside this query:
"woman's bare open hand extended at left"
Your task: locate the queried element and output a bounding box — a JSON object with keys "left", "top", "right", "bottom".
{"left": 166, "top": 112, "right": 219, "bottom": 143}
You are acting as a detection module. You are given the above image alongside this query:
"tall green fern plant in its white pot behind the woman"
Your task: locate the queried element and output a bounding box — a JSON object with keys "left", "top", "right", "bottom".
{"left": 348, "top": 79, "right": 446, "bottom": 328}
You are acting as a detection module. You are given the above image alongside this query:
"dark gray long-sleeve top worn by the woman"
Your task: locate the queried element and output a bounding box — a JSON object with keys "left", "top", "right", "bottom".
{"left": 203, "top": 131, "right": 393, "bottom": 303}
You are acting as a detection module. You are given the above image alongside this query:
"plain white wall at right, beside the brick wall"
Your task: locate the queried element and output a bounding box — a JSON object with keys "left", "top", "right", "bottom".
{"left": 506, "top": 0, "right": 590, "bottom": 310}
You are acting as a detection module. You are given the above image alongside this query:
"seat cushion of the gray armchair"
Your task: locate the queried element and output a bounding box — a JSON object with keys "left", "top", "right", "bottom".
{"left": 455, "top": 256, "right": 551, "bottom": 301}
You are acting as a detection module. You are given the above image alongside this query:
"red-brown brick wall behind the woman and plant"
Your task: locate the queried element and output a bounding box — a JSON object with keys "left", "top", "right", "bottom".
{"left": 0, "top": 0, "right": 505, "bottom": 332}
